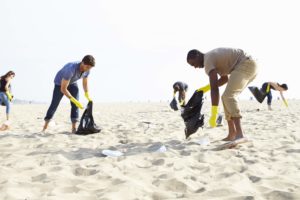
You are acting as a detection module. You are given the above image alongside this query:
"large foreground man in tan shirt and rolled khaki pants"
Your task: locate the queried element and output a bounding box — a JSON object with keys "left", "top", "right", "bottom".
{"left": 187, "top": 48, "right": 257, "bottom": 143}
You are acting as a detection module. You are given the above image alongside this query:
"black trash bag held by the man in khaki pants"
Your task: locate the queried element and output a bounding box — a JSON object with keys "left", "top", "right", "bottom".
{"left": 181, "top": 91, "right": 204, "bottom": 139}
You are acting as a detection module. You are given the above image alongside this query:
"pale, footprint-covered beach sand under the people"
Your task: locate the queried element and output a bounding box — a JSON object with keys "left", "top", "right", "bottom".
{"left": 0, "top": 100, "right": 300, "bottom": 200}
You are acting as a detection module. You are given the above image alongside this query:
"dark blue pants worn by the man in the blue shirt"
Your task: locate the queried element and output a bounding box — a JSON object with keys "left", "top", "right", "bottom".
{"left": 45, "top": 83, "right": 79, "bottom": 123}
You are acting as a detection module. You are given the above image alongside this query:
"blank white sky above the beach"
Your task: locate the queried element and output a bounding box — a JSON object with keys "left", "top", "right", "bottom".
{"left": 0, "top": 0, "right": 300, "bottom": 102}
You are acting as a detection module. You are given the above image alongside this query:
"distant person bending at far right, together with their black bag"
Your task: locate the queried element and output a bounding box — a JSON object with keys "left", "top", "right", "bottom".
{"left": 249, "top": 82, "right": 288, "bottom": 110}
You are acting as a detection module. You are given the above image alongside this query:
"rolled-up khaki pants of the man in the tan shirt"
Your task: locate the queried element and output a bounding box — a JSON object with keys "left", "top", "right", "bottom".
{"left": 222, "top": 59, "right": 257, "bottom": 120}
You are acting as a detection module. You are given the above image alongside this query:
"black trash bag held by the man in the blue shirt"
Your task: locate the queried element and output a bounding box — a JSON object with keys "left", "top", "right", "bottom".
{"left": 76, "top": 101, "right": 101, "bottom": 135}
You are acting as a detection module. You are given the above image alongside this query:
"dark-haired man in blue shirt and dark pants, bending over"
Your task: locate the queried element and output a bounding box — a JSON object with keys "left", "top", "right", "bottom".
{"left": 43, "top": 55, "right": 95, "bottom": 133}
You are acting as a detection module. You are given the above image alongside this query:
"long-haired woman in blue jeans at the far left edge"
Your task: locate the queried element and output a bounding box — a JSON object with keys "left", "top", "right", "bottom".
{"left": 0, "top": 71, "right": 15, "bottom": 131}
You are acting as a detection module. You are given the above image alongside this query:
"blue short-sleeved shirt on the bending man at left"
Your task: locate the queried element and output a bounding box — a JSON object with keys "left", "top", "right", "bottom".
{"left": 54, "top": 62, "right": 90, "bottom": 85}
